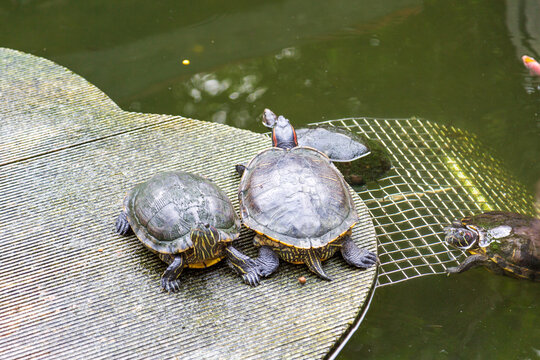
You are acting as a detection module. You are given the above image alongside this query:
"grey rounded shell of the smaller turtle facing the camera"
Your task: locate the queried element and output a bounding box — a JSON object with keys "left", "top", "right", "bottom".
{"left": 124, "top": 171, "right": 239, "bottom": 254}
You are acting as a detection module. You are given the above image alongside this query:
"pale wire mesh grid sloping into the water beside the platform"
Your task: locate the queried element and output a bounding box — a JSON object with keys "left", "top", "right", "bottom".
{"left": 312, "top": 118, "right": 534, "bottom": 286}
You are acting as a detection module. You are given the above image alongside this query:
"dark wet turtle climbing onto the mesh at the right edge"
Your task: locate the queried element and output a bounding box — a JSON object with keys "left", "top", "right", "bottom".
{"left": 445, "top": 211, "right": 540, "bottom": 281}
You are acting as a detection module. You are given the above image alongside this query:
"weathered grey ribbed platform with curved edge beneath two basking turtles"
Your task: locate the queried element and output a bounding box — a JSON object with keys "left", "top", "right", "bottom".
{"left": 0, "top": 49, "right": 376, "bottom": 359}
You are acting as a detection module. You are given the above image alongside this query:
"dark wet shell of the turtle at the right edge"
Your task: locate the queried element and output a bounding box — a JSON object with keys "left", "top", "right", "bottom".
{"left": 462, "top": 211, "right": 540, "bottom": 280}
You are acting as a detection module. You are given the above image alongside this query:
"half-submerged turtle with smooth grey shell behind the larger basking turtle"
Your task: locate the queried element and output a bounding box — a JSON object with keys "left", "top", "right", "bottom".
{"left": 294, "top": 123, "right": 392, "bottom": 186}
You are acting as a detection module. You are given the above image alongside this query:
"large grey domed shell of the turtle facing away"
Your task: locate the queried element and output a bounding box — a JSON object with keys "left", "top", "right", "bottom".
{"left": 238, "top": 147, "right": 358, "bottom": 249}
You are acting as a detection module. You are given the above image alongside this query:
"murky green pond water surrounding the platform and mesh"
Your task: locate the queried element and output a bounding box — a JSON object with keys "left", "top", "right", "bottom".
{"left": 0, "top": 0, "right": 540, "bottom": 359}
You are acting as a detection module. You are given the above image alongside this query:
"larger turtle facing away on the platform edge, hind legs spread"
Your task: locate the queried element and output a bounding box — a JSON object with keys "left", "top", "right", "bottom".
{"left": 237, "top": 109, "right": 377, "bottom": 280}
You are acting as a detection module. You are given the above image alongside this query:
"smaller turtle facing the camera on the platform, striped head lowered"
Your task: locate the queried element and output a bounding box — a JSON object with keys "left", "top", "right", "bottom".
{"left": 116, "top": 171, "right": 260, "bottom": 292}
